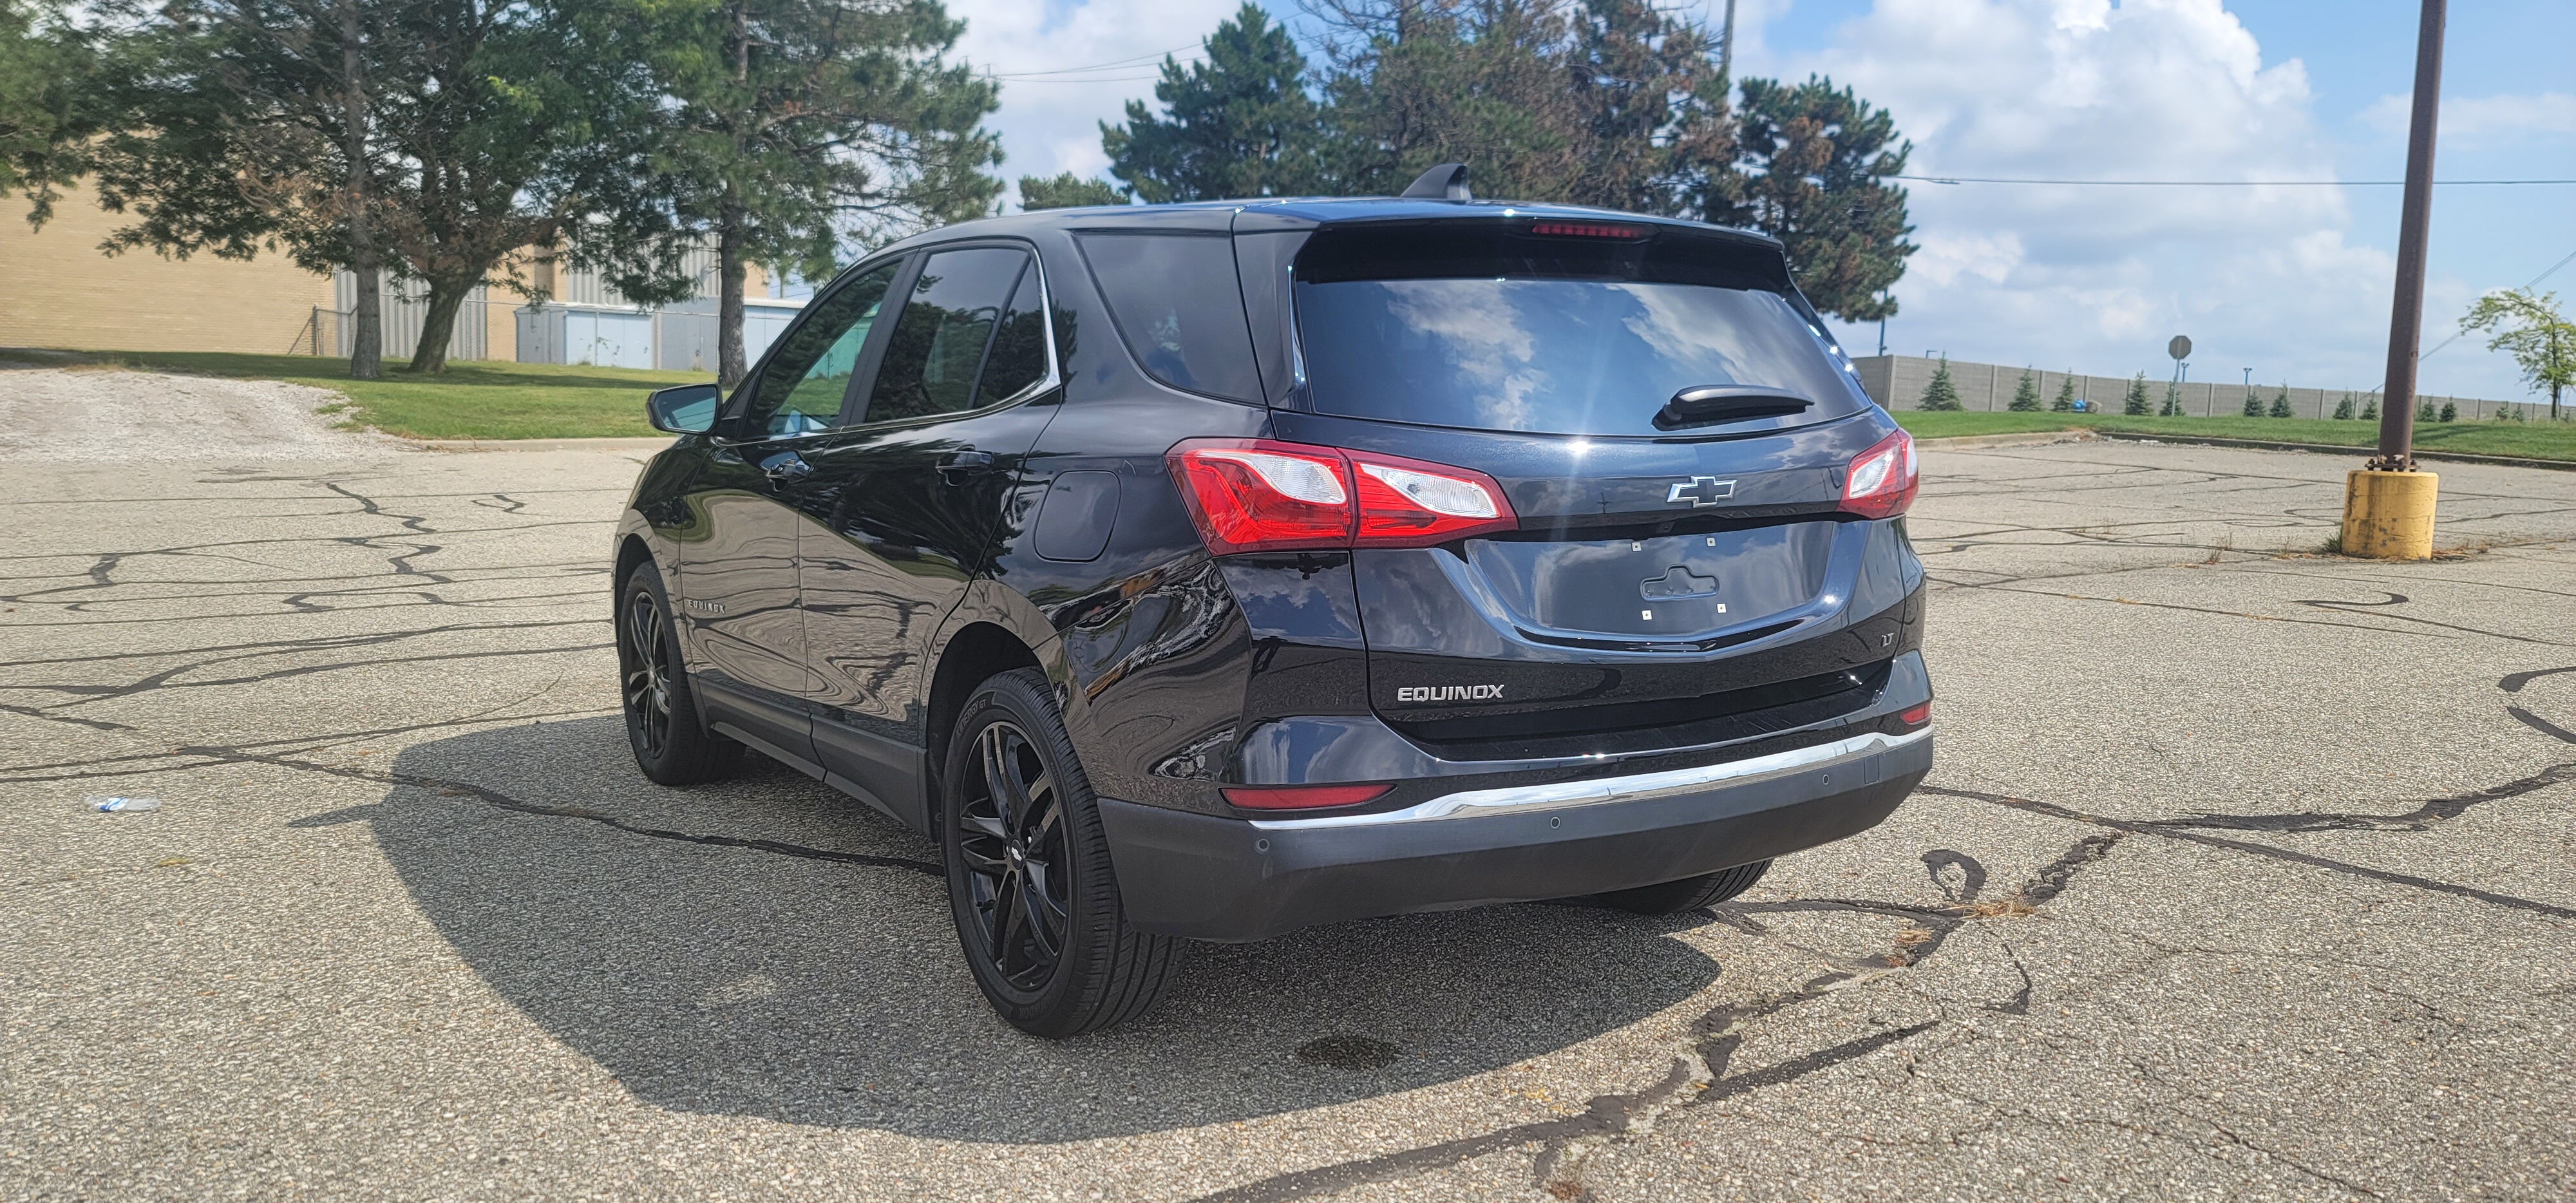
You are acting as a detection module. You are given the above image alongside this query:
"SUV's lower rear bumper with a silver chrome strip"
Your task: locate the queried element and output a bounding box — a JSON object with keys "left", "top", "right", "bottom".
{"left": 1100, "top": 729, "right": 1932, "bottom": 940}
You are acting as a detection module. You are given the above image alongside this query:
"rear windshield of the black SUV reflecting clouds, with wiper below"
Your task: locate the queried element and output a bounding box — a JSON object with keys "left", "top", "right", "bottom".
{"left": 1296, "top": 227, "right": 1860, "bottom": 435}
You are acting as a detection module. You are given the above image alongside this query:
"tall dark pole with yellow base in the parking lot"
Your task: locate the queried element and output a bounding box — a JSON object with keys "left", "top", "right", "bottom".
{"left": 2342, "top": 0, "right": 2447, "bottom": 559}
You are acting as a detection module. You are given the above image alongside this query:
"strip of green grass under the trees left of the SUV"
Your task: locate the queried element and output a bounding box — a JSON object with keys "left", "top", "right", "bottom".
{"left": 8, "top": 350, "right": 714, "bottom": 438}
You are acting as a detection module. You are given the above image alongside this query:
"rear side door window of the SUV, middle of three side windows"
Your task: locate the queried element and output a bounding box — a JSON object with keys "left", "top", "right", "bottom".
{"left": 860, "top": 247, "right": 1043, "bottom": 422}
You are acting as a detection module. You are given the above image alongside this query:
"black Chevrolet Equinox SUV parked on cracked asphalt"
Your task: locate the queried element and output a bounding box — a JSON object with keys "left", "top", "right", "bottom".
{"left": 616, "top": 173, "right": 1932, "bottom": 1036}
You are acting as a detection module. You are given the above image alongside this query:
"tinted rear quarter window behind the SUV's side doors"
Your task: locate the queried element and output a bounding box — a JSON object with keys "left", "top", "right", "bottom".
{"left": 1082, "top": 234, "right": 1262, "bottom": 402}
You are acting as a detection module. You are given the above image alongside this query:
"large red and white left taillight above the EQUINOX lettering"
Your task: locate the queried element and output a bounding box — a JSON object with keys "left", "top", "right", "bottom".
{"left": 1164, "top": 438, "right": 1520, "bottom": 556}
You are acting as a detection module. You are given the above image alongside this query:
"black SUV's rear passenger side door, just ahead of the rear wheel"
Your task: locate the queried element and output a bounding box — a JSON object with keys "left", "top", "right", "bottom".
{"left": 791, "top": 245, "right": 1056, "bottom": 822}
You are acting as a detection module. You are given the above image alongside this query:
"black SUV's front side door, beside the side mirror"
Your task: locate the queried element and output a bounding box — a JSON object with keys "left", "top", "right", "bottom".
{"left": 680, "top": 263, "right": 902, "bottom": 765}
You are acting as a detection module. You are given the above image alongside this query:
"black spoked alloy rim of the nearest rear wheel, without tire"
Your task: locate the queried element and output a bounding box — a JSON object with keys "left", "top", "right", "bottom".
{"left": 956, "top": 721, "right": 1072, "bottom": 992}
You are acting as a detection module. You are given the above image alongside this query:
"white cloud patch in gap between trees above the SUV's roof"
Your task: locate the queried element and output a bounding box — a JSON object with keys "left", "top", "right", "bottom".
{"left": 948, "top": 0, "right": 1239, "bottom": 207}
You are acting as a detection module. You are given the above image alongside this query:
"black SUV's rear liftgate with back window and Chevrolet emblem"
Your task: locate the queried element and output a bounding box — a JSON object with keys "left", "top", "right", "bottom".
{"left": 1275, "top": 222, "right": 1906, "bottom": 757}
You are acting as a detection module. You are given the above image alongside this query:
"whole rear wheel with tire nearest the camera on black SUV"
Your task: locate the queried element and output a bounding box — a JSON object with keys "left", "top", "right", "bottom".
{"left": 938, "top": 670, "right": 1180, "bottom": 1038}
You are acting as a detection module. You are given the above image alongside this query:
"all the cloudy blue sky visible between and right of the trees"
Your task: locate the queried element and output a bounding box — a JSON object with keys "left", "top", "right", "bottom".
{"left": 951, "top": 0, "right": 2576, "bottom": 399}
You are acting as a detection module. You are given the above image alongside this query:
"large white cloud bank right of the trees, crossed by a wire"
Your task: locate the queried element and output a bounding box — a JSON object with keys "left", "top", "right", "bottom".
{"left": 1739, "top": 0, "right": 2524, "bottom": 399}
